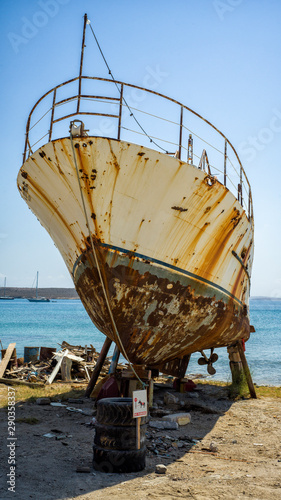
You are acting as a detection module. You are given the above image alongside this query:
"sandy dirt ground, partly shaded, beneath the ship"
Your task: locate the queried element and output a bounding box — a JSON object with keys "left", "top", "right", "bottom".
{"left": 0, "top": 384, "right": 281, "bottom": 500}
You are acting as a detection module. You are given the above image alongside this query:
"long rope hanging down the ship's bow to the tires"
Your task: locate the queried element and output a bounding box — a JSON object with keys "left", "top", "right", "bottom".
{"left": 70, "top": 133, "right": 145, "bottom": 388}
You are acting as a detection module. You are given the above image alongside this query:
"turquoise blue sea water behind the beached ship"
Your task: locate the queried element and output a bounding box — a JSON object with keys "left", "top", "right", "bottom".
{"left": 0, "top": 298, "right": 281, "bottom": 386}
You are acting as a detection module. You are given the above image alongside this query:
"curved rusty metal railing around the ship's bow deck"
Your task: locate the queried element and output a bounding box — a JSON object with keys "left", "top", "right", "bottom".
{"left": 23, "top": 74, "right": 253, "bottom": 220}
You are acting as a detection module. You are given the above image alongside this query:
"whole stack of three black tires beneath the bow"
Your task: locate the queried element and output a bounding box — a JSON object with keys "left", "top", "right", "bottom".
{"left": 93, "top": 398, "right": 147, "bottom": 473}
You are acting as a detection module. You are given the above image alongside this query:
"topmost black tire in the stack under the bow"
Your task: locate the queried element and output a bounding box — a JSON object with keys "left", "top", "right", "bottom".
{"left": 96, "top": 398, "right": 148, "bottom": 426}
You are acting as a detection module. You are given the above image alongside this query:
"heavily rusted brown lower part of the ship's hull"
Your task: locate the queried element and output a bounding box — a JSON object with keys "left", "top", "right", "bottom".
{"left": 74, "top": 248, "right": 250, "bottom": 366}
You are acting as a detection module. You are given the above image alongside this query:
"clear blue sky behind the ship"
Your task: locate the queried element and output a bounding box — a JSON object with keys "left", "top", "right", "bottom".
{"left": 0, "top": 0, "right": 281, "bottom": 297}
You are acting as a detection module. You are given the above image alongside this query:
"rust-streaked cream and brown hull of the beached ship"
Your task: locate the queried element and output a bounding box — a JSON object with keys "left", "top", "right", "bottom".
{"left": 18, "top": 137, "right": 253, "bottom": 366}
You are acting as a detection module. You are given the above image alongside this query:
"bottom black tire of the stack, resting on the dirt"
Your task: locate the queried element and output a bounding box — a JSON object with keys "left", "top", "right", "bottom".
{"left": 93, "top": 445, "right": 146, "bottom": 473}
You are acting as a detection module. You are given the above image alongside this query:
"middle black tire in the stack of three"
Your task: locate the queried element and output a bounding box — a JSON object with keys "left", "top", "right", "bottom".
{"left": 94, "top": 424, "right": 147, "bottom": 451}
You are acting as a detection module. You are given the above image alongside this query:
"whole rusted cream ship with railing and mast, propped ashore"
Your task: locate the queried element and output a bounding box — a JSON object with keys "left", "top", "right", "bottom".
{"left": 18, "top": 17, "right": 254, "bottom": 373}
